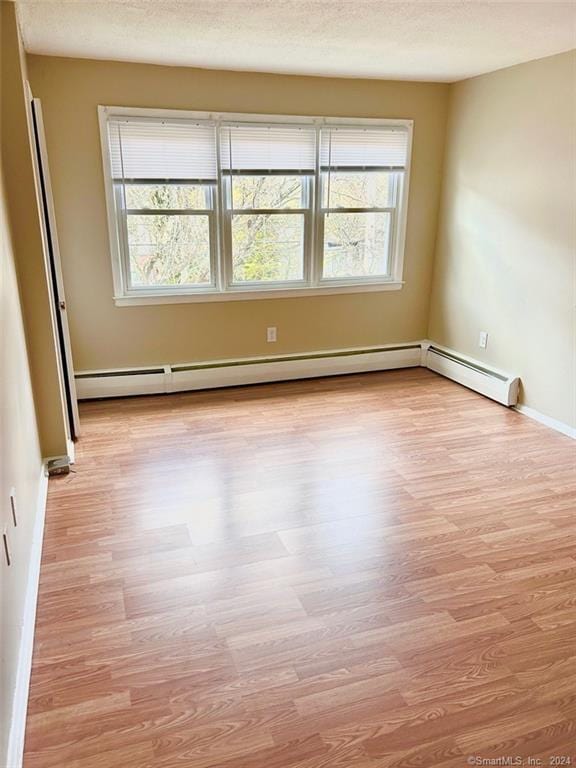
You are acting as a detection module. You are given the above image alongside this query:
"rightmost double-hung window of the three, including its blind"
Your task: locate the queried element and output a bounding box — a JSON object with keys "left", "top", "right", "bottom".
{"left": 318, "top": 125, "right": 408, "bottom": 283}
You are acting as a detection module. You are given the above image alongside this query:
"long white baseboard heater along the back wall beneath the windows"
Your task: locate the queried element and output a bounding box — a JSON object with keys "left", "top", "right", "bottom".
{"left": 75, "top": 342, "right": 422, "bottom": 400}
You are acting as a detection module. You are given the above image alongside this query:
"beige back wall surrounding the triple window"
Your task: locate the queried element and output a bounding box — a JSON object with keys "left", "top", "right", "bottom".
{"left": 28, "top": 56, "right": 448, "bottom": 370}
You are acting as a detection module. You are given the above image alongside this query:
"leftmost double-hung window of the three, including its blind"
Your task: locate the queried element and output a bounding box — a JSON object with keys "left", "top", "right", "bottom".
{"left": 108, "top": 117, "right": 218, "bottom": 293}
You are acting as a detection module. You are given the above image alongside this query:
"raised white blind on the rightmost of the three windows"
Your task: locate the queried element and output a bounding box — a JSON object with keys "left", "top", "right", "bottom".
{"left": 320, "top": 126, "right": 408, "bottom": 171}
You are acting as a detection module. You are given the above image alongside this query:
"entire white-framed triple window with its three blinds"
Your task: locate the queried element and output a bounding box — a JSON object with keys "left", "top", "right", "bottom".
{"left": 100, "top": 107, "right": 411, "bottom": 304}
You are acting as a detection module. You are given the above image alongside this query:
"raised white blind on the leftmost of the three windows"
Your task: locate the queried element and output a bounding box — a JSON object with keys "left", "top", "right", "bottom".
{"left": 108, "top": 118, "right": 218, "bottom": 183}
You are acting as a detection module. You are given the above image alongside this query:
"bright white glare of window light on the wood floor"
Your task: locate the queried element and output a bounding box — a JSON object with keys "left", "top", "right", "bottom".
{"left": 120, "top": 413, "right": 402, "bottom": 549}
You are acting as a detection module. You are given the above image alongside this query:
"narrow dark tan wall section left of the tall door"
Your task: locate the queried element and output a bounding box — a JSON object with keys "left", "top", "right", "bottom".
{"left": 1, "top": 2, "right": 67, "bottom": 456}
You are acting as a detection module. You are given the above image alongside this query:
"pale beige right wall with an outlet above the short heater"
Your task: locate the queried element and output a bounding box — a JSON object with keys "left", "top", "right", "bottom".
{"left": 429, "top": 52, "right": 576, "bottom": 426}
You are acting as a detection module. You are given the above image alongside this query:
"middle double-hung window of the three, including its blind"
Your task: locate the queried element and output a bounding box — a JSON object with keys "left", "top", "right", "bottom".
{"left": 220, "top": 122, "right": 316, "bottom": 289}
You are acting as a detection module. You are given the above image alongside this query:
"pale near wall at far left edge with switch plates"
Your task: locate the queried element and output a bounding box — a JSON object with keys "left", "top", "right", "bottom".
{"left": 0, "top": 9, "right": 42, "bottom": 765}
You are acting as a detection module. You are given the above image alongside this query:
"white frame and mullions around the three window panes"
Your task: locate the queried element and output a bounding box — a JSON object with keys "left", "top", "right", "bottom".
{"left": 98, "top": 106, "right": 413, "bottom": 306}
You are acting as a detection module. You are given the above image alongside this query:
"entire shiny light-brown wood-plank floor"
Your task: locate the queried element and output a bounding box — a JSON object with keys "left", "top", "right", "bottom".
{"left": 25, "top": 369, "right": 576, "bottom": 768}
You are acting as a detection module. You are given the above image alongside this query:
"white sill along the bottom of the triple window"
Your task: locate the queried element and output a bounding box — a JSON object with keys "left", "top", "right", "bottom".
{"left": 114, "top": 281, "right": 404, "bottom": 307}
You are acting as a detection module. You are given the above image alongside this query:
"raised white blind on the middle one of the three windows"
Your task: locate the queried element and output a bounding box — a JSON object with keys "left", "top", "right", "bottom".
{"left": 220, "top": 124, "right": 316, "bottom": 175}
